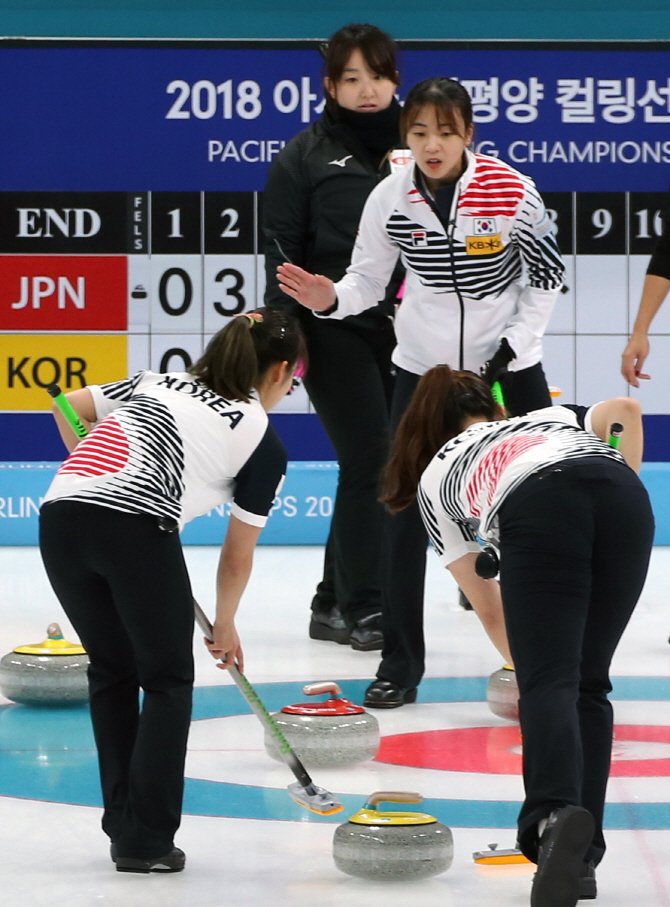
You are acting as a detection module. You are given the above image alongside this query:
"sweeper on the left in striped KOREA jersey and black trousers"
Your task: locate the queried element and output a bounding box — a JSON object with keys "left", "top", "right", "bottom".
{"left": 40, "top": 309, "right": 305, "bottom": 873}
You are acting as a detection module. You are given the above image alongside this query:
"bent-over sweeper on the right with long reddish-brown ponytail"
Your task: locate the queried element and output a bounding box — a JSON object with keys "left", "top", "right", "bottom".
{"left": 383, "top": 365, "right": 654, "bottom": 907}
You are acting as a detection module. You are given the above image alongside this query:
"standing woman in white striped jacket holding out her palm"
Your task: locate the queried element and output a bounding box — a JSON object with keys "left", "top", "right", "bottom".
{"left": 277, "top": 78, "right": 564, "bottom": 708}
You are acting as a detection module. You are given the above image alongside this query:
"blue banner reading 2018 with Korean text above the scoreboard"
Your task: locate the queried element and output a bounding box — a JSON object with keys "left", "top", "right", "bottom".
{"left": 0, "top": 40, "right": 670, "bottom": 192}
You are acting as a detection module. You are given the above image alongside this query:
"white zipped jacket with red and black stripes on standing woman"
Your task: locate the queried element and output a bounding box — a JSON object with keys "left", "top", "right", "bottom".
{"left": 329, "top": 151, "right": 564, "bottom": 374}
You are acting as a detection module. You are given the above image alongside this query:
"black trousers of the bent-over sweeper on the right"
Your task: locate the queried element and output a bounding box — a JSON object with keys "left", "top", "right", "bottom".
{"left": 499, "top": 457, "right": 654, "bottom": 863}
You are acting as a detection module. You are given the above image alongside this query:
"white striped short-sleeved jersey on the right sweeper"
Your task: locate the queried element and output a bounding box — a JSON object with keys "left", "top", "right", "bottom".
{"left": 417, "top": 406, "right": 623, "bottom": 567}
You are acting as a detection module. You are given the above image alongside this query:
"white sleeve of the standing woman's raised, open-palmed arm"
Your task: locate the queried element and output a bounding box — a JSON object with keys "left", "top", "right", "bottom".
{"left": 327, "top": 177, "right": 399, "bottom": 318}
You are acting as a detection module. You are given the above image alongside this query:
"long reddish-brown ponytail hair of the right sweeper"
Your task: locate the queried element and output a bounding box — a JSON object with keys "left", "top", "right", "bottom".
{"left": 380, "top": 365, "right": 498, "bottom": 513}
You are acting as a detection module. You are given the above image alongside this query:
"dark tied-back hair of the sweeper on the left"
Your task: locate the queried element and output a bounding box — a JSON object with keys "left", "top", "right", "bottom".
{"left": 189, "top": 308, "right": 307, "bottom": 402}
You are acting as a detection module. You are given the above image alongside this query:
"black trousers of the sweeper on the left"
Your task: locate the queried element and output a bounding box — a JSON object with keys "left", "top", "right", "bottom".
{"left": 40, "top": 500, "right": 193, "bottom": 859}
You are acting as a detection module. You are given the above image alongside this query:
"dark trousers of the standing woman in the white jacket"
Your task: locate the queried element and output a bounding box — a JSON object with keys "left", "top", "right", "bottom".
{"left": 377, "top": 363, "right": 551, "bottom": 689}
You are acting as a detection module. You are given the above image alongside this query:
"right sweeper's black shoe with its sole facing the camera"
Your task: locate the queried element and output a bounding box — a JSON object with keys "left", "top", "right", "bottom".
{"left": 530, "top": 806, "right": 595, "bottom": 907}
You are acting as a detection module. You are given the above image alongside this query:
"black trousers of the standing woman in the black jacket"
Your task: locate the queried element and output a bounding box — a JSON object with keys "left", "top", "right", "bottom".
{"left": 301, "top": 312, "right": 395, "bottom": 629}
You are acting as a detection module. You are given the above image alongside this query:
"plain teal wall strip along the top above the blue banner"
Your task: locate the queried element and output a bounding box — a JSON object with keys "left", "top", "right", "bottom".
{"left": 0, "top": 0, "right": 670, "bottom": 41}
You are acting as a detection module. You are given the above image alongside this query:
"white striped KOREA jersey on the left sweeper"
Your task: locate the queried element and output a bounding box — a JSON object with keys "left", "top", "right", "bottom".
{"left": 44, "top": 371, "right": 286, "bottom": 529}
